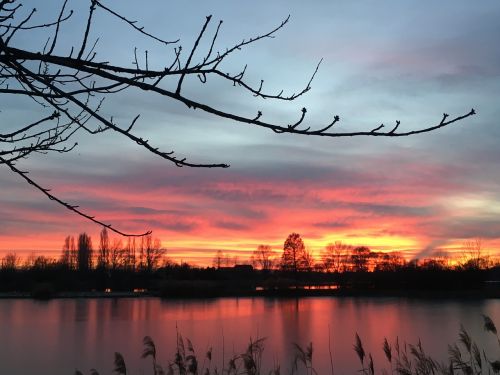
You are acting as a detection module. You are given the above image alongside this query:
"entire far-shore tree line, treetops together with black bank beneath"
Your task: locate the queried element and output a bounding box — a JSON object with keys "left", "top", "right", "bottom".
{"left": 0, "top": 229, "right": 500, "bottom": 298}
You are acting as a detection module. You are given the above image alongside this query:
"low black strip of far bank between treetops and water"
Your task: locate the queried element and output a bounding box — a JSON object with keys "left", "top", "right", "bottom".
{"left": 0, "top": 268, "right": 500, "bottom": 300}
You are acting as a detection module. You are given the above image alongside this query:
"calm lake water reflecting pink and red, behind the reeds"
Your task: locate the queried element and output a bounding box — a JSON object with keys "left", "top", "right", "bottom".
{"left": 0, "top": 298, "right": 500, "bottom": 375}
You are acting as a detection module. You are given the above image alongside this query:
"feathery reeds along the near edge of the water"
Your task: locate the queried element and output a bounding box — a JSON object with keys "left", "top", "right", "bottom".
{"left": 75, "top": 315, "right": 500, "bottom": 375}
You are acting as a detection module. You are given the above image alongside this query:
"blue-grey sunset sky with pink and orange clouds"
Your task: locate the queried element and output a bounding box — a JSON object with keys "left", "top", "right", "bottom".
{"left": 0, "top": 0, "right": 500, "bottom": 265}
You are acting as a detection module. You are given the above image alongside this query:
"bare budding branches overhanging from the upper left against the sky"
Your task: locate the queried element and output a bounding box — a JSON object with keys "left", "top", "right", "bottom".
{"left": 0, "top": 0, "right": 475, "bottom": 236}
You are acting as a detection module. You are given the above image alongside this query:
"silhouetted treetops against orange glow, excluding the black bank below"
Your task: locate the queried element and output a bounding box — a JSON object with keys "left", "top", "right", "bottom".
{"left": 1, "top": 228, "right": 497, "bottom": 273}
